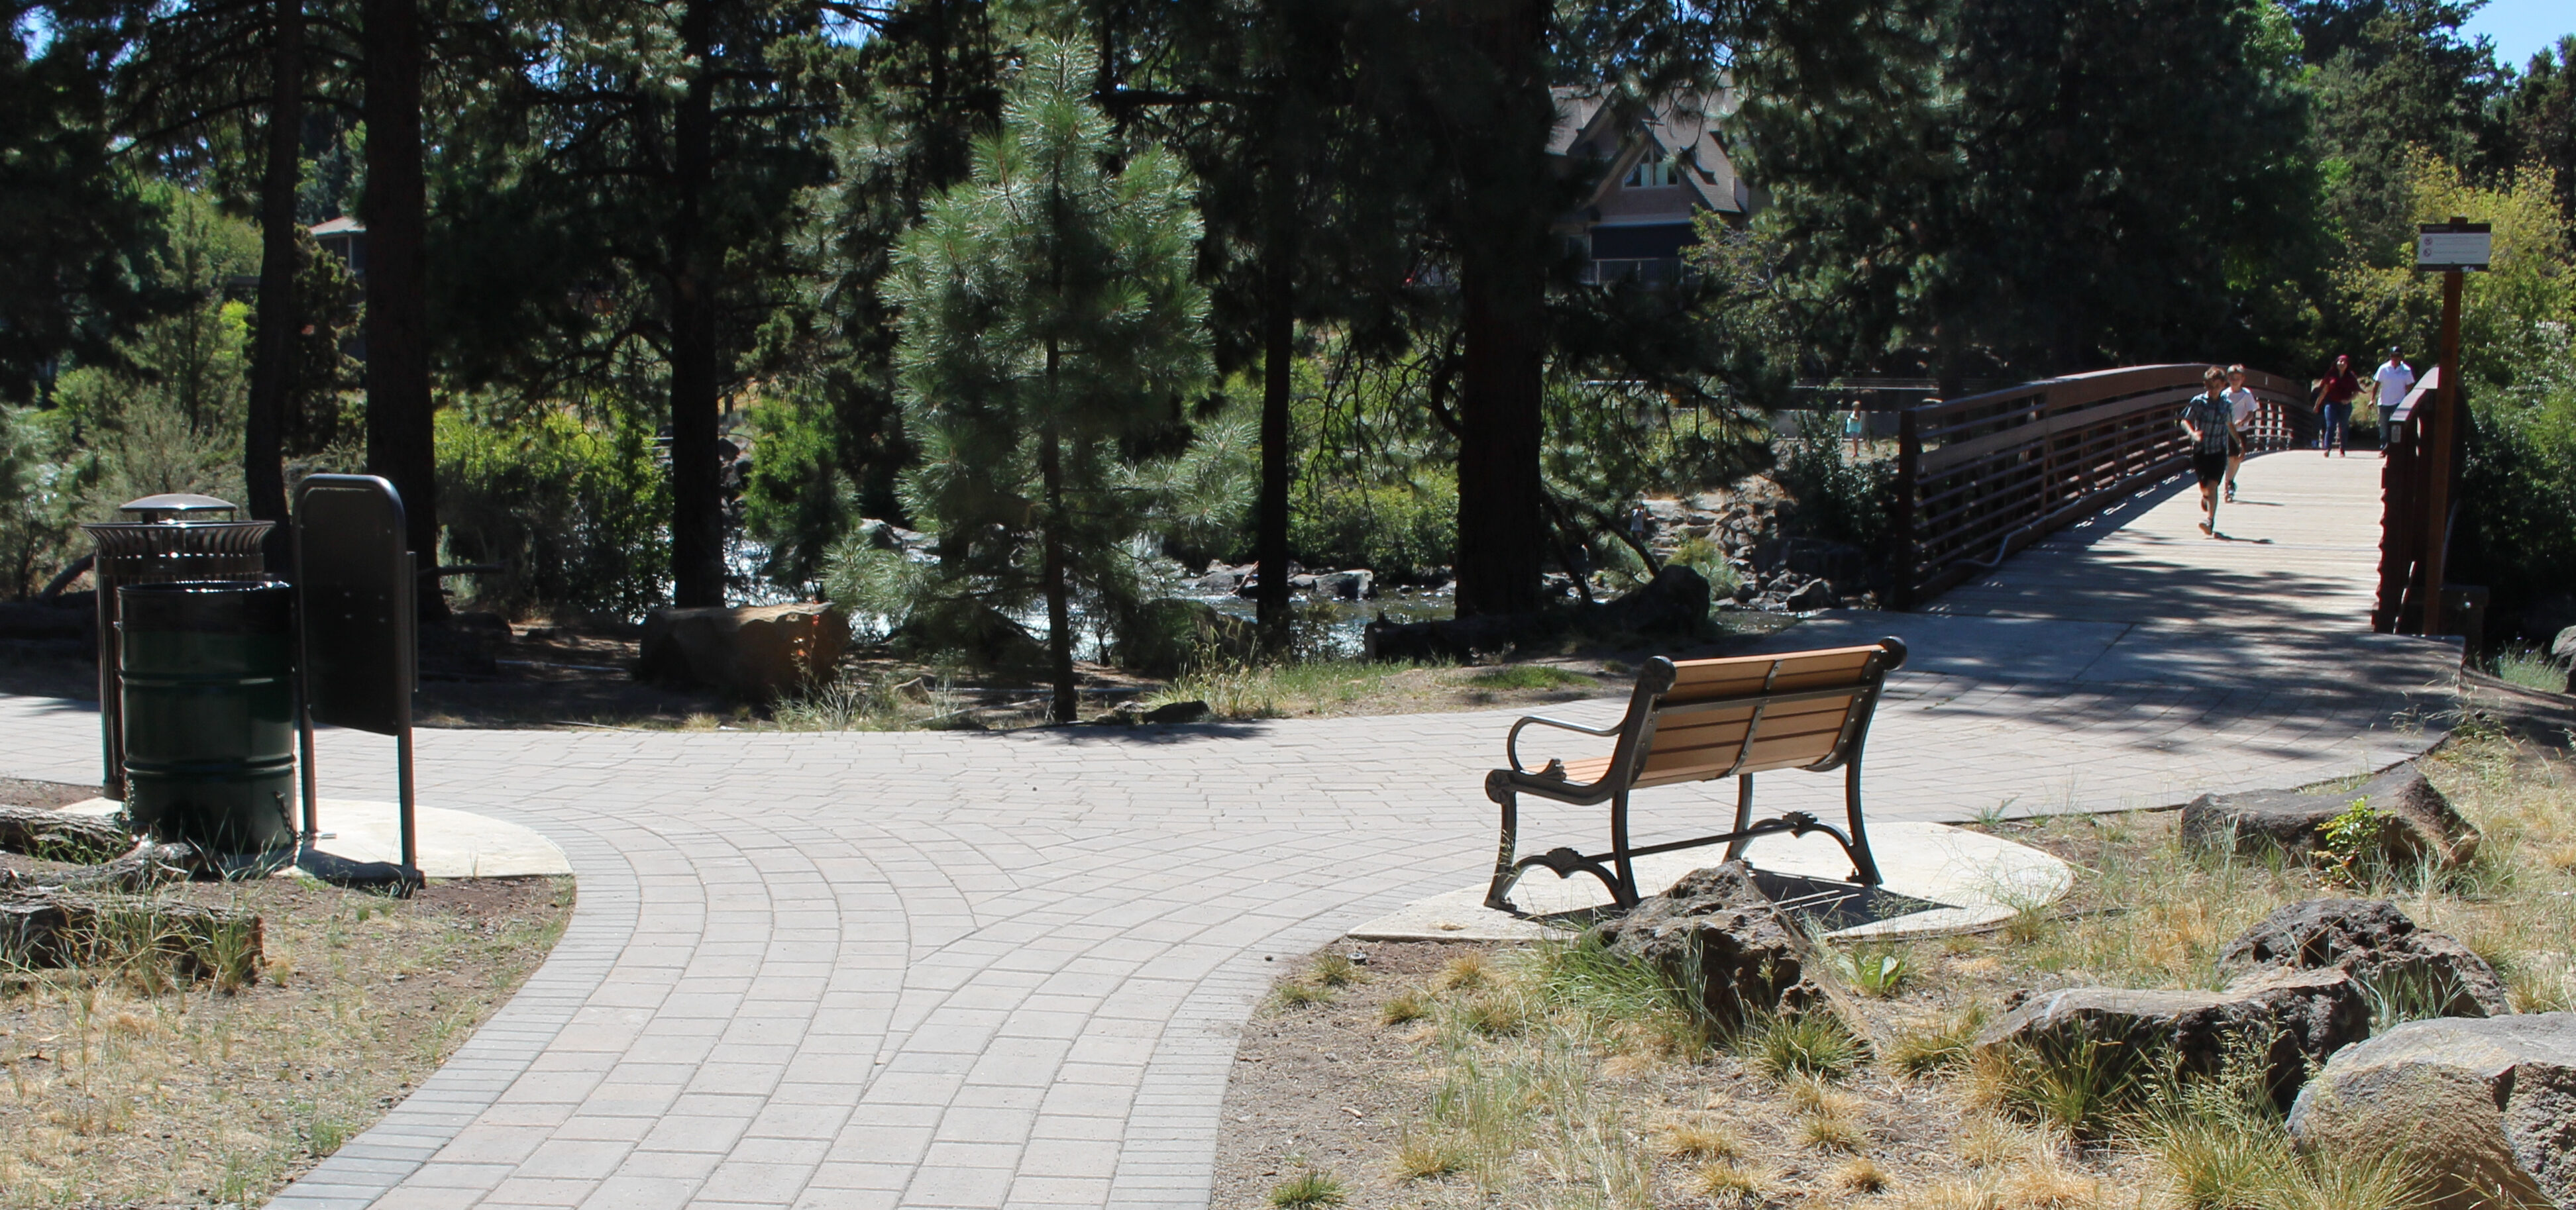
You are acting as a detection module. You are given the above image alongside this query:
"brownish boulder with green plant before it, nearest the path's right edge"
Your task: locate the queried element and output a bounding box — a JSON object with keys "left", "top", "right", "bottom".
{"left": 2182, "top": 762, "right": 2478, "bottom": 870}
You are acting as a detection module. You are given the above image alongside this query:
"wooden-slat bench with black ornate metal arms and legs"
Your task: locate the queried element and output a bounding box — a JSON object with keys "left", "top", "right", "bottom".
{"left": 1483, "top": 638, "right": 1906, "bottom": 911}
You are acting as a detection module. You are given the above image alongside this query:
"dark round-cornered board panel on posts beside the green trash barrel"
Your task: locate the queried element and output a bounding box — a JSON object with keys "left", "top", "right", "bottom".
{"left": 296, "top": 474, "right": 417, "bottom": 736}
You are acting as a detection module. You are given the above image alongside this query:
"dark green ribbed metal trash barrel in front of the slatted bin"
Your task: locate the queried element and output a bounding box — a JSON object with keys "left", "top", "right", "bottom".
{"left": 116, "top": 580, "right": 296, "bottom": 852}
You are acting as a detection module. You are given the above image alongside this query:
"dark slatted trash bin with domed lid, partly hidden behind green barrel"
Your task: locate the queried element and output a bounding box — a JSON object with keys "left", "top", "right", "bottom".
{"left": 82, "top": 491, "right": 276, "bottom": 798}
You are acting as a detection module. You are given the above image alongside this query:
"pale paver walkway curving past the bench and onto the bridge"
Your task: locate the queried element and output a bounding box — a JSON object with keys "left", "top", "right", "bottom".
{"left": 0, "top": 456, "right": 2455, "bottom": 1210}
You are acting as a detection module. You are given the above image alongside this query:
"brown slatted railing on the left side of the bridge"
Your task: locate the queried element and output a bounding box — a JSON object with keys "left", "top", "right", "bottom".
{"left": 1891, "top": 363, "right": 2316, "bottom": 607}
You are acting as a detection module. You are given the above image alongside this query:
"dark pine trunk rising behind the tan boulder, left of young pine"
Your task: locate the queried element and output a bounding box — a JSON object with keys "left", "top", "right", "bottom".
{"left": 667, "top": 0, "right": 724, "bottom": 607}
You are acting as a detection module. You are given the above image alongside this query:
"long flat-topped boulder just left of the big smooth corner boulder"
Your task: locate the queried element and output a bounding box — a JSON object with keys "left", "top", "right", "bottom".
{"left": 1976, "top": 968, "right": 2370, "bottom": 1105}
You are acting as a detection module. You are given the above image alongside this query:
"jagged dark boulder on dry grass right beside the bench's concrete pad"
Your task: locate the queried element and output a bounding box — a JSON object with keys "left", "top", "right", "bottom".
{"left": 1592, "top": 862, "right": 1857, "bottom": 1022}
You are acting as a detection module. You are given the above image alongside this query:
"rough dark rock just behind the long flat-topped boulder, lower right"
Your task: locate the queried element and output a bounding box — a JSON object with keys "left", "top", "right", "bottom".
{"left": 2218, "top": 899, "right": 2514, "bottom": 1017}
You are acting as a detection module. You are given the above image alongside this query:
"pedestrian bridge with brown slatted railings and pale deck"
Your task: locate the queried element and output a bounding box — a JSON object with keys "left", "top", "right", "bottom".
{"left": 1891, "top": 363, "right": 2473, "bottom": 630}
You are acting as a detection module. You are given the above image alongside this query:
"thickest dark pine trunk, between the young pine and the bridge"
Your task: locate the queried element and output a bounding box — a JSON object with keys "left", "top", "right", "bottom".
{"left": 1450, "top": 0, "right": 1556, "bottom": 618}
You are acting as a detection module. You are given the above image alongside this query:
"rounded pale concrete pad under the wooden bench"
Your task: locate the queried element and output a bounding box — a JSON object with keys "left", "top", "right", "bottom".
{"left": 1350, "top": 821, "right": 2074, "bottom": 942}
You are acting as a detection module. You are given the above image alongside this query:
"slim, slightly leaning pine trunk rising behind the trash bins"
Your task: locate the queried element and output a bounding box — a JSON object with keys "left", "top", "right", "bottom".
{"left": 242, "top": 0, "right": 304, "bottom": 556}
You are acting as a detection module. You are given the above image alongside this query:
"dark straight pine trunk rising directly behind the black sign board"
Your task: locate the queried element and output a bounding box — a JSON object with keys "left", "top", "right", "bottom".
{"left": 366, "top": 0, "right": 449, "bottom": 618}
